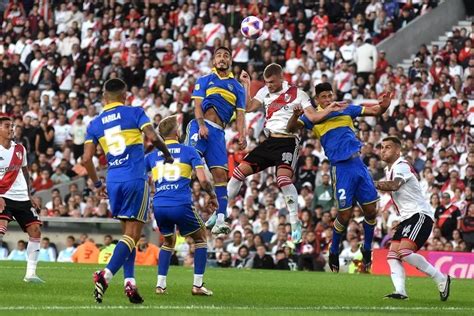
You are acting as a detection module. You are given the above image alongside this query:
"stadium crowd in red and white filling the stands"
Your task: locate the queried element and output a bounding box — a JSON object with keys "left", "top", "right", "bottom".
{"left": 0, "top": 0, "right": 474, "bottom": 270}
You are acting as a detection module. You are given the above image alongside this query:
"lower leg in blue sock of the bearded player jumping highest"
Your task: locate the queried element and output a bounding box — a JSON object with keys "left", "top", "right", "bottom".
{"left": 211, "top": 167, "right": 230, "bottom": 235}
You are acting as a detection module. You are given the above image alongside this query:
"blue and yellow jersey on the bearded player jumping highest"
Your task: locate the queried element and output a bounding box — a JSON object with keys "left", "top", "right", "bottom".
{"left": 192, "top": 69, "right": 246, "bottom": 125}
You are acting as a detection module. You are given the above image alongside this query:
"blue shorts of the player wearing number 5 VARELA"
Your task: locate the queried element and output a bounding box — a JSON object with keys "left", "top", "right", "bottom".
{"left": 107, "top": 179, "right": 150, "bottom": 222}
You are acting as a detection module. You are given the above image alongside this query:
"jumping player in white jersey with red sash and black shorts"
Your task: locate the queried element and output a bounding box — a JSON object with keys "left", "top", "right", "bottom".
{"left": 227, "top": 64, "right": 342, "bottom": 243}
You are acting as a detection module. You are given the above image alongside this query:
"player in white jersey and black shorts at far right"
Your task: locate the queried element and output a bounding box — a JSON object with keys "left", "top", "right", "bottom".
{"left": 375, "top": 137, "right": 451, "bottom": 301}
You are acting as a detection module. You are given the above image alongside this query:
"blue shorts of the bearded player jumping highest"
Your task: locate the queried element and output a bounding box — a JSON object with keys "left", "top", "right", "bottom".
{"left": 185, "top": 120, "right": 228, "bottom": 170}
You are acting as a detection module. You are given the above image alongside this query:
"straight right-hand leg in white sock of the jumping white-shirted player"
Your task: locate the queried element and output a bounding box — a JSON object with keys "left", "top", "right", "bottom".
{"left": 277, "top": 165, "right": 301, "bottom": 244}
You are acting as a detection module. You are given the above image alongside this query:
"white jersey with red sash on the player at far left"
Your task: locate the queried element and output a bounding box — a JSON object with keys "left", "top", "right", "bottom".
{"left": 0, "top": 142, "right": 29, "bottom": 201}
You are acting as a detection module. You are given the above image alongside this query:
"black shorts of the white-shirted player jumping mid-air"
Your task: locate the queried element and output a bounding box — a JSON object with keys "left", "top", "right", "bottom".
{"left": 242, "top": 137, "right": 299, "bottom": 173}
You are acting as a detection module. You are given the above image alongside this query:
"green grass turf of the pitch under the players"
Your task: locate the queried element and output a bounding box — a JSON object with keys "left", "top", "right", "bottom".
{"left": 0, "top": 261, "right": 474, "bottom": 316}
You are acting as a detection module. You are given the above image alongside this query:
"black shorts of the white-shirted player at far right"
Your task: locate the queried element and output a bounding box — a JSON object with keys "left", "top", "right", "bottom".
{"left": 392, "top": 213, "right": 433, "bottom": 249}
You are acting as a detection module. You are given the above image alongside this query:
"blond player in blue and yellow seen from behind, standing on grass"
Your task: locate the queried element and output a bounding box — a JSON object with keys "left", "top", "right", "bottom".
{"left": 145, "top": 115, "right": 217, "bottom": 296}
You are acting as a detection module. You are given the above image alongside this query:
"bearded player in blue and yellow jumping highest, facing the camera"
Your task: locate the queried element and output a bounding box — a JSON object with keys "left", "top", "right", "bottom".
{"left": 185, "top": 47, "right": 248, "bottom": 235}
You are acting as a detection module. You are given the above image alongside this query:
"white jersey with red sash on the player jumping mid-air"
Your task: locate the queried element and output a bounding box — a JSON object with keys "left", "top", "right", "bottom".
{"left": 254, "top": 82, "right": 312, "bottom": 136}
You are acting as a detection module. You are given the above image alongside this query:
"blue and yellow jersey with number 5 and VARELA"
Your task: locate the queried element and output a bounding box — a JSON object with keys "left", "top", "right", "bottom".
{"left": 85, "top": 102, "right": 151, "bottom": 182}
